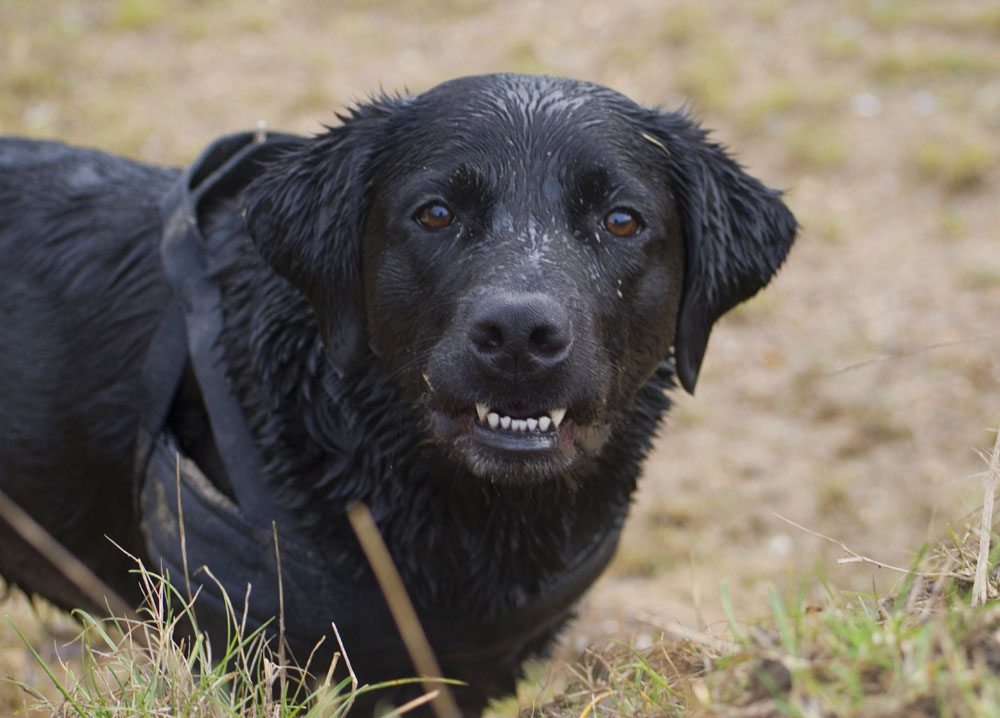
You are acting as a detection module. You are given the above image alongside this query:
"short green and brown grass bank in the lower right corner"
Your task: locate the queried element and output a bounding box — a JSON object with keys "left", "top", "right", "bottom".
{"left": 521, "top": 529, "right": 1000, "bottom": 718}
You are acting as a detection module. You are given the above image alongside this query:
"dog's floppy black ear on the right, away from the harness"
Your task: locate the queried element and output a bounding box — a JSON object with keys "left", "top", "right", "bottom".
{"left": 647, "top": 113, "right": 798, "bottom": 393}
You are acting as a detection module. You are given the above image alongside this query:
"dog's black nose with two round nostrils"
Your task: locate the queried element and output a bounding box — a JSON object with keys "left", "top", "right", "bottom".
{"left": 469, "top": 294, "right": 573, "bottom": 376}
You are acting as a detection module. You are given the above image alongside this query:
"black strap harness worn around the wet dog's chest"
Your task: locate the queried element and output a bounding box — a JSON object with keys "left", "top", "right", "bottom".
{"left": 136, "top": 133, "right": 619, "bottom": 681}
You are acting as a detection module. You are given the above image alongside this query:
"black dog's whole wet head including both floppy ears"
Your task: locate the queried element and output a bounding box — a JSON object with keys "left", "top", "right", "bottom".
{"left": 247, "top": 75, "right": 796, "bottom": 482}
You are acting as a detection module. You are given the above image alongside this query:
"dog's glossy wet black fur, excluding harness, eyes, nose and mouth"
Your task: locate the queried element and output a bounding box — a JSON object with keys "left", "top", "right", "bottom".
{"left": 0, "top": 75, "right": 796, "bottom": 713}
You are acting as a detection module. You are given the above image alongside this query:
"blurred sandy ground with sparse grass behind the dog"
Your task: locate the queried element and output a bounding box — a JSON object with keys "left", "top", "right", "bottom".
{"left": 0, "top": 0, "right": 1000, "bottom": 713}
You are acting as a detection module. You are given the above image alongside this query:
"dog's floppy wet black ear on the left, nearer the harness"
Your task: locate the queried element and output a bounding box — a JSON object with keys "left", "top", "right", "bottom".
{"left": 243, "top": 108, "right": 392, "bottom": 374}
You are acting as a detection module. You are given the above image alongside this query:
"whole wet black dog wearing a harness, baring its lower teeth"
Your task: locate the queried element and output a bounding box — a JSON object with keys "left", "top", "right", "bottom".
{"left": 0, "top": 75, "right": 796, "bottom": 714}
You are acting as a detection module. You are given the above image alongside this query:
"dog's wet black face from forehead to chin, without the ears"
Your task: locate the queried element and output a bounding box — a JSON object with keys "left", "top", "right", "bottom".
{"left": 362, "top": 78, "right": 684, "bottom": 483}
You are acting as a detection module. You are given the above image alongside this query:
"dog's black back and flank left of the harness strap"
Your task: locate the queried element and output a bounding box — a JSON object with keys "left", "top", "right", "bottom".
{"left": 0, "top": 138, "right": 177, "bottom": 606}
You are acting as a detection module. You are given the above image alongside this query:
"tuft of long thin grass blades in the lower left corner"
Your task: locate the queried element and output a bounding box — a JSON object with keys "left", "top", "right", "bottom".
{"left": 6, "top": 548, "right": 435, "bottom": 718}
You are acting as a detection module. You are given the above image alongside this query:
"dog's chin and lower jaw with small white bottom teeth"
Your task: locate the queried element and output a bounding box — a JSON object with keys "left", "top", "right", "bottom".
{"left": 430, "top": 411, "right": 607, "bottom": 485}
